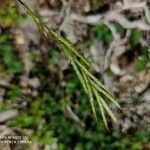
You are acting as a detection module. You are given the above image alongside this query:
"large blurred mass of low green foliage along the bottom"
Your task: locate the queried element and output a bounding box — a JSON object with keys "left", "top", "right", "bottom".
{"left": 8, "top": 67, "right": 149, "bottom": 150}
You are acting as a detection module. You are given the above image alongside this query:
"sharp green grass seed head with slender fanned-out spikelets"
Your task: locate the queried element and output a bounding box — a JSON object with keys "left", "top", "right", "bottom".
{"left": 18, "top": 0, "right": 120, "bottom": 127}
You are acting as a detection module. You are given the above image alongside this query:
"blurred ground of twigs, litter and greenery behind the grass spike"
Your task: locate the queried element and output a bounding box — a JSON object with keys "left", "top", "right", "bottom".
{"left": 0, "top": 0, "right": 150, "bottom": 150}
